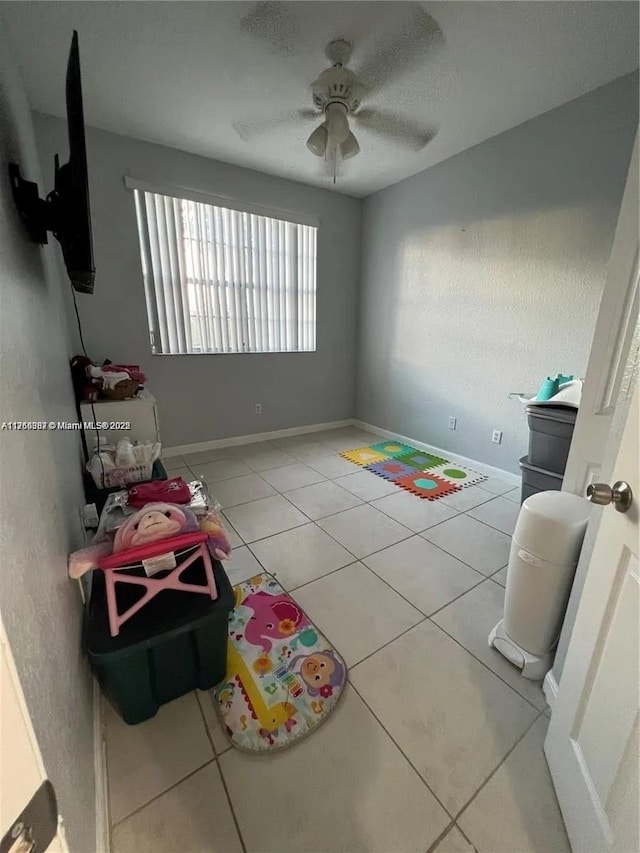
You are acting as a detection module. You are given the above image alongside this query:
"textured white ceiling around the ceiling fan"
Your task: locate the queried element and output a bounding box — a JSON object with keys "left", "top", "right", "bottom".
{"left": 2, "top": 0, "right": 638, "bottom": 196}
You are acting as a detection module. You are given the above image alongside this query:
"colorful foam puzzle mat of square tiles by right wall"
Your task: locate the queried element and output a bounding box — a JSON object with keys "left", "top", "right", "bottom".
{"left": 340, "top": 441, "right": 487, "bottom": 501}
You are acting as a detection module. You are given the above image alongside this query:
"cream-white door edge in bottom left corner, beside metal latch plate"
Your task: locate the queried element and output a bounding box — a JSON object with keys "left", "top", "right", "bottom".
{"left": 0, "top": 623, "right": 67, "bottom": 853}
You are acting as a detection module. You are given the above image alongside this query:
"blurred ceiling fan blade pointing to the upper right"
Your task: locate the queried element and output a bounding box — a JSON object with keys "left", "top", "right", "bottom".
{"left": 358, "top": 3, "right": 444, "bottom": 93}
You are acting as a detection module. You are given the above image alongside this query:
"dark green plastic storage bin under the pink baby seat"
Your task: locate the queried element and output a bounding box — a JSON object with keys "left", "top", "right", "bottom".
{"left": 83, "top": 561, "right": 235, "bottom": 725}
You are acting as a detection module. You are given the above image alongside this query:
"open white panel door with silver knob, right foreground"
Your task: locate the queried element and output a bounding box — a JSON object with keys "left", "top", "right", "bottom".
{"left": 545, "top": 380, "right": 640, "bottom": 853}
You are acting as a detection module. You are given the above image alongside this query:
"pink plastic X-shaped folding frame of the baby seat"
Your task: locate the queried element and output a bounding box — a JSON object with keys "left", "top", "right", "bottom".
{"left": 98, "top": 532, "right": 218, "bottom": 637}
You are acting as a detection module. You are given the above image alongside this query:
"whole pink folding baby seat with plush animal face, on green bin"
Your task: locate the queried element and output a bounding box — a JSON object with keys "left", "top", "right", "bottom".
{"left": 69, "top": 503, "right": 231, "bottom": 637}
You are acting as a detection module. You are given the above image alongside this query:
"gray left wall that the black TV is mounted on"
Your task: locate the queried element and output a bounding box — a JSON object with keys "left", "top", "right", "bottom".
{"left": 0, "top": 11, "right": 96, "bottom": 853}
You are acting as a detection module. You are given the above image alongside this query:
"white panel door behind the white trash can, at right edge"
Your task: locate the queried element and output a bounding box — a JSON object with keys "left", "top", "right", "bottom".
{"left": 562, "top": 137, "right": 639, "bottom": 496}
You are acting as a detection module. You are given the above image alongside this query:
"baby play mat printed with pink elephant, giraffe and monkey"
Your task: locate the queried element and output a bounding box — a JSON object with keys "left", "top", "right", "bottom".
{"left": 214, "top": 573, "right": 347, "bottom": 752}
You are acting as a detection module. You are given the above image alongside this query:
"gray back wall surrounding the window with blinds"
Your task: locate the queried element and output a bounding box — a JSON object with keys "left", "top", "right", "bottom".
{"left": 35, "top": 114, "right": 362, "bottom": 446}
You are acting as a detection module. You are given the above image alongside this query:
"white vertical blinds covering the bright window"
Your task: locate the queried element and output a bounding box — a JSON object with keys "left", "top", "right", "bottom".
{"left": 134, "top": 189, "right": 317, "bottom": 354}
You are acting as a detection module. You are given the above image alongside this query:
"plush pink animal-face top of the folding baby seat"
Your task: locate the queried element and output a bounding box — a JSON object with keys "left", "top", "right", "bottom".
{"left": 69, "top": 503, "right": 231, "bottom": 578}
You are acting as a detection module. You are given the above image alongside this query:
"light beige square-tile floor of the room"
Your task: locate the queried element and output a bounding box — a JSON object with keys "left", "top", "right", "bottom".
{"left": 105, "top": 428, "right": 570, "bottom": 853}
